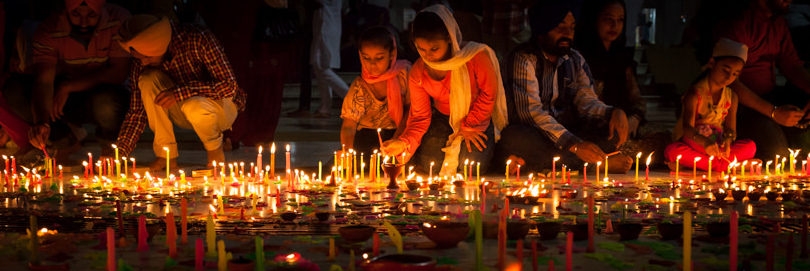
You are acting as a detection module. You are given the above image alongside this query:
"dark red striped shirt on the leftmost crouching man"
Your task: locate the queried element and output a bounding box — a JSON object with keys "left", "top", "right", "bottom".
{"left": 33, "top": 4, "right": 130, "bottom": 77}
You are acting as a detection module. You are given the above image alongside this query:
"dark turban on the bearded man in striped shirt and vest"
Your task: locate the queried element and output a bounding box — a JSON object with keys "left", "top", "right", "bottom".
{"left": 529, "top": 0, "right": 582, "bottom": 37}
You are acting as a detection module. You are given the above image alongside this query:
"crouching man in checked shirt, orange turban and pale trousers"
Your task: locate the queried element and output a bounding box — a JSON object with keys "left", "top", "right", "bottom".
{"left": 117, "top": 15, "right": 245, "bottom": 171}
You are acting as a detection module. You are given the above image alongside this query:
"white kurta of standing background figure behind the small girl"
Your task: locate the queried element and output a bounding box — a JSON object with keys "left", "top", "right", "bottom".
{"left": 309, "top": 0, "right": 343, "bottom": 68}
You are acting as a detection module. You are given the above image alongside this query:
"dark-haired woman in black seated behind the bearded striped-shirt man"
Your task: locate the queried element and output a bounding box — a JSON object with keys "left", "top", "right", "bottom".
{"left": 574, "top": 0, "right": 671, "bottom": 162}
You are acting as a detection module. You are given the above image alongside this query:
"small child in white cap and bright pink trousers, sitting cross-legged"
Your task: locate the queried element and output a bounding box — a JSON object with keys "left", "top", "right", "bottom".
{"left": 664, "top": 38, "right": 757, "bottom": 171}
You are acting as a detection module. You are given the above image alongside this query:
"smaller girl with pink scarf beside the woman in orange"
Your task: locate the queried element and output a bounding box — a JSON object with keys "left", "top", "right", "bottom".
{"left": 340, "top": 27, "right": 411, "bottom": 161}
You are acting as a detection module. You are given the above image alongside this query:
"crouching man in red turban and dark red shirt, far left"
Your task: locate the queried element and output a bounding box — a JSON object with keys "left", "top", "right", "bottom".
{"left": 17, "top": 0, "right": 131, "bottom": 162}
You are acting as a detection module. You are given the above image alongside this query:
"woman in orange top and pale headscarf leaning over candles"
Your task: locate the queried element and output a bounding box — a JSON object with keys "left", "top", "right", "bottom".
{"left": 383, "top": 5, "right": 507, "bottom": 178}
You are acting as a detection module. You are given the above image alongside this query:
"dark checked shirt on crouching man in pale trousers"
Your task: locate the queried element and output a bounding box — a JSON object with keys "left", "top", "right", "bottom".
{"left": 117, "top": 22, "right": 246, "bottom": 155}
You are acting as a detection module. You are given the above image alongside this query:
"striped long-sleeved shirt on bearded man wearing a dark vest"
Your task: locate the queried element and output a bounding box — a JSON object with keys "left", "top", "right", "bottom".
{"left": 504, "top": 45, "right": 612, "bottom": 150}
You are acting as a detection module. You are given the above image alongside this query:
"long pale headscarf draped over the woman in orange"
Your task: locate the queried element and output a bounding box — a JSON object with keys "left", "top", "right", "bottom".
{"left": 420, "top": 5, "right": 508, "bottom": 176}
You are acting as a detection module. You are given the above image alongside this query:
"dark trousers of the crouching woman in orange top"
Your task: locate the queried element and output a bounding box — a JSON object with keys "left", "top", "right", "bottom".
{"left": 411, "top": 108, "right": 495, "bottom": 174}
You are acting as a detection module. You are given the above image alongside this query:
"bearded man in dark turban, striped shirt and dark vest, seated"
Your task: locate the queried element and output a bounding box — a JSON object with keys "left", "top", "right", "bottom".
{"left": 496, "top": 0, "right": 632, "bottom": 172}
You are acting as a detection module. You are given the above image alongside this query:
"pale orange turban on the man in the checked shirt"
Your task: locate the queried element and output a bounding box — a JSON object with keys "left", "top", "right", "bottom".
{"left": 118, "top": 14, "right": 172, "bottom": 56}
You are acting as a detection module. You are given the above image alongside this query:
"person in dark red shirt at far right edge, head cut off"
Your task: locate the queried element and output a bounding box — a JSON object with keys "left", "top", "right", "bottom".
{"left": 715, "top": 0, "right": 810, "bottom": 160}
